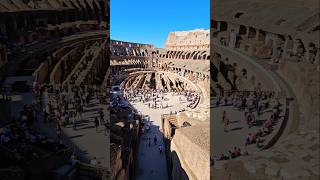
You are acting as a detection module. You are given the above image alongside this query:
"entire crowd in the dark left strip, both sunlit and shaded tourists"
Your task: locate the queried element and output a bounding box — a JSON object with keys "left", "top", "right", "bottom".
{"left": 0, "top": 74, "right": 107, "bottom": 173}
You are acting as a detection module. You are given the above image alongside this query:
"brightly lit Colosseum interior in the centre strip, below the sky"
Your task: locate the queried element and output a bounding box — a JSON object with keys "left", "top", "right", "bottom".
{"left": 110, "top": 29, "right": 210, "bottom": 180}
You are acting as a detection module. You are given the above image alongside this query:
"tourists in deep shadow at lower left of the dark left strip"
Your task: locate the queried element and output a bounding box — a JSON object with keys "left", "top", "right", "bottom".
{"left": 0, "top": 102, "right": 66, "bottom": 162}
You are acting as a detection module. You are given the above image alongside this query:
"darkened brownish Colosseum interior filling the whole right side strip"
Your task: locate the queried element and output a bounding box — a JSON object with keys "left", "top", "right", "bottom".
{"left": 210, "top": 0, "right": 320, "bottom": 180}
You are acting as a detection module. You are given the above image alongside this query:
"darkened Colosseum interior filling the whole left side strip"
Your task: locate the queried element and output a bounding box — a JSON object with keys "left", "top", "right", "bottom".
{"left": 0, "top": 0, "right": 111, "bottom": 180}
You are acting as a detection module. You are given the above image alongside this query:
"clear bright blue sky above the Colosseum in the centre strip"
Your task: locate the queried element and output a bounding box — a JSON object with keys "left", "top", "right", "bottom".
{"left": 110, "top": 0, "right": 210, "bottom": 47}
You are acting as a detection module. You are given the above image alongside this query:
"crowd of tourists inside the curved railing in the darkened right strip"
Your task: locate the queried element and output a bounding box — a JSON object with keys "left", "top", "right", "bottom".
{"left": 215, "top": 91, "right": 281, "bottom": 160}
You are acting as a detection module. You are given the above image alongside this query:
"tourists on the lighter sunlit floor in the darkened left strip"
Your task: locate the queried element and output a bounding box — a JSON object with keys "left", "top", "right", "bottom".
{"left": 33, "top": 83, "right": 106, "bottom": 137}
